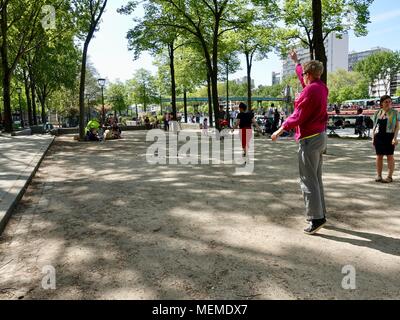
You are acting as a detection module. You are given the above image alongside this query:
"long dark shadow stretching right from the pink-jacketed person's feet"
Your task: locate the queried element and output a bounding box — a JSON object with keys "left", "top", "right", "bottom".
{"left": 317, "top": 226, "right": 400, "bottom": 256}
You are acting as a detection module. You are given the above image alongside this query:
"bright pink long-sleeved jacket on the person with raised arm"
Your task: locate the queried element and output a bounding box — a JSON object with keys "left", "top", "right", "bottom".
{"left": 282, "top": 64, "right": 329, "bottom": 140}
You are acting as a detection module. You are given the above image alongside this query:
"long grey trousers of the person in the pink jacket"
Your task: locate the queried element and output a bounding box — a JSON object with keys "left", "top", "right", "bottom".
{"left": 299, "top": 132, "right": 327, "bottom": 219}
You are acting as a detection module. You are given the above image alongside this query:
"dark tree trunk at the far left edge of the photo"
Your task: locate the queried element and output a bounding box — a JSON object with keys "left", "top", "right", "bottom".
{"left": 0, "top": 4, "right": 13, "bottom": 132}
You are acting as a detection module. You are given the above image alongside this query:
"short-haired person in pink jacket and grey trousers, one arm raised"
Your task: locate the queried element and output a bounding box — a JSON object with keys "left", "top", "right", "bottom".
{"left": 271, "top": 51, "right": 329, "bottom": 234}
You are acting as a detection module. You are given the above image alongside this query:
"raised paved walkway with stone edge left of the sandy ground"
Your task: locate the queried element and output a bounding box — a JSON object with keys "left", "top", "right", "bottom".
{"left": 0, "top": 135, "right": 54, "bottom": 234}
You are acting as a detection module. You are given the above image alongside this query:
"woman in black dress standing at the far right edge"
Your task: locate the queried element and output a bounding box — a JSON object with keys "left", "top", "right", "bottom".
{"left": 372, "top": 95, "right": 399, "bottom": 183}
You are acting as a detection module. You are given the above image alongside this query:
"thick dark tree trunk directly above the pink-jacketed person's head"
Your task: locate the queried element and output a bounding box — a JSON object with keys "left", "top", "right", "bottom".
{"left": 312, "top": 0, "right": 328, "bottom": 84}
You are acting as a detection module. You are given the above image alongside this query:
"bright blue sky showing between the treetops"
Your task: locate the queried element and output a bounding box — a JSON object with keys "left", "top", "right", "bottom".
{"left": 89, "top": 0, "right": 400, "bottom": 86}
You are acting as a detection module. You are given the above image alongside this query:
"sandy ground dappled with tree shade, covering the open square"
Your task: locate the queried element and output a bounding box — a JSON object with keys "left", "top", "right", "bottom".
{"left": 0, "top": 132, "right": 400, "bottom": 299}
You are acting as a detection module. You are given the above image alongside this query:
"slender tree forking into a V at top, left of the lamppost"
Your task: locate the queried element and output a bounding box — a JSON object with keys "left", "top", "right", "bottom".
{"left": 72, "top": 0, "right": 107, "bottom": 140}
